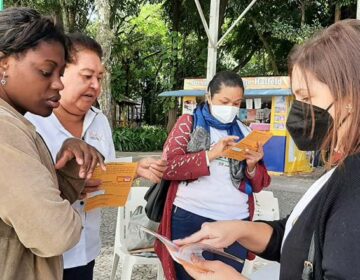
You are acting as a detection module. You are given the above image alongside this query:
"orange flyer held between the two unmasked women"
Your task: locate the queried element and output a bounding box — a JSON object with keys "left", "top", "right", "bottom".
{"left": 85, "top": 162, "right": 137, "bottom": 211}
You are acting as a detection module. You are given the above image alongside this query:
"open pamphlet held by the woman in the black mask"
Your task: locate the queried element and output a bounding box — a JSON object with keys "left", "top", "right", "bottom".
{"left": 139, "top": 225, "right": 244, "bottom": 272}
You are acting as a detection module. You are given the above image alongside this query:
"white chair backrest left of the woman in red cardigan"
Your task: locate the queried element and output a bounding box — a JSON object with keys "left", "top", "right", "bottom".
{"left": 115, "top": 187, "right": 149, "bottom": 251}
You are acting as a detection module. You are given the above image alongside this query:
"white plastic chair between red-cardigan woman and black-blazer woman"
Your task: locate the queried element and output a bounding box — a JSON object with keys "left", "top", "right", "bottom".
{"left": 242, "top": 191, "right": 280, "bottom": 279}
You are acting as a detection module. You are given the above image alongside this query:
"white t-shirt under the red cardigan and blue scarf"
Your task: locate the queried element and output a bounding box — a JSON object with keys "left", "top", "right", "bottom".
{"left": 174, "top": 122, "right": 250, "bottom": 221}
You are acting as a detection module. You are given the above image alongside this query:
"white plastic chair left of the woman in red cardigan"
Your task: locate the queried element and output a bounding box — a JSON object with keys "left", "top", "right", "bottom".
{"left": 110, "top": 187, "right": 164, "bottom": 280}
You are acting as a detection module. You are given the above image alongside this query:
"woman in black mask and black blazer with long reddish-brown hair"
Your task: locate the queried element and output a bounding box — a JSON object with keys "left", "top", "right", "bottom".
{"left": 177, "top": 20, "right": 360, "bottom": 280}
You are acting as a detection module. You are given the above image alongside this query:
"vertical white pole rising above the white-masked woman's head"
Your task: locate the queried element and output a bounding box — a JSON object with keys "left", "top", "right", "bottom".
{"left": 206, "top": 0, "right": 220, "bottom": 82}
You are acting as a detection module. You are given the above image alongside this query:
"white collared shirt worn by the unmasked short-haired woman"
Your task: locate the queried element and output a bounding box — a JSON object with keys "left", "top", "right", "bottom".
{"left": 25, "top": 107, "right": 115, "bottom": 268}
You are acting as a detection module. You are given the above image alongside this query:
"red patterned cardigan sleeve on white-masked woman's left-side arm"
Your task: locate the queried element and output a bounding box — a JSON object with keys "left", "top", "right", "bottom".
{"left": 163, "top": 115, "right": 210, "bottom": 181}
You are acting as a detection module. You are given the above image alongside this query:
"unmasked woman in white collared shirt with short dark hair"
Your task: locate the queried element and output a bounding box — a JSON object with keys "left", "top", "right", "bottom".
{"left": 26, "top": 34, "right": 165, "bottom": 280}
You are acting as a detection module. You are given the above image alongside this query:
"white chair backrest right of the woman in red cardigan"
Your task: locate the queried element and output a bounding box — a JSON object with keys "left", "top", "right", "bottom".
{"left": 254, "top": 191, "right": 280, "bottom": 221}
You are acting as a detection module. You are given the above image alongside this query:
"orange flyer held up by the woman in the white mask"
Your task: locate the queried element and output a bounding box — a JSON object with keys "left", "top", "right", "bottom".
{"left": 224, "top": 130, "right": 272, "bottom": 161}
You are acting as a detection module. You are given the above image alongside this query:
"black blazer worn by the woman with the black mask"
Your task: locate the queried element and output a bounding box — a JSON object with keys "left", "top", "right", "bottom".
{"left": 259, "top": 154, "right": 360, "bottom": 280}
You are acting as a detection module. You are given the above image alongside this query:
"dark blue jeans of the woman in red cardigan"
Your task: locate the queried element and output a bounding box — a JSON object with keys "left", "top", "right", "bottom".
{"left": 171, "top": 206, "right": 247, "bottom": 280}
